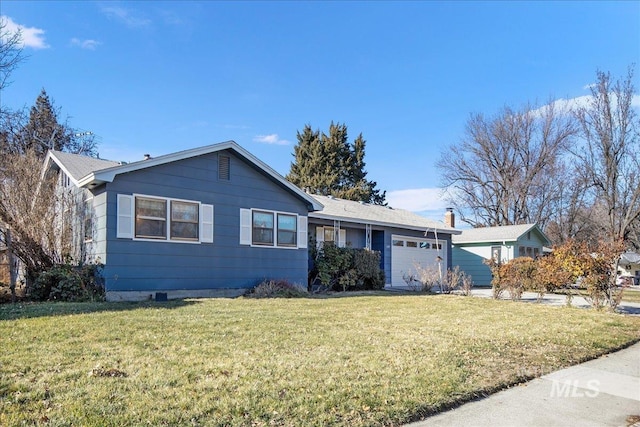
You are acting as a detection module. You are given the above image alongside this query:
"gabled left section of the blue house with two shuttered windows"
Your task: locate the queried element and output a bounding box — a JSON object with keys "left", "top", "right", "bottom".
{"left": 45, "top": 141, "right": 322, "bottom": 301}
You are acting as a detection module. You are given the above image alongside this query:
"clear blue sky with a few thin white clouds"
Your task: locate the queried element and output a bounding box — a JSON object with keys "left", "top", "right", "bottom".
{"left": 0, "top": 0, "right": 640, "bottom": 219}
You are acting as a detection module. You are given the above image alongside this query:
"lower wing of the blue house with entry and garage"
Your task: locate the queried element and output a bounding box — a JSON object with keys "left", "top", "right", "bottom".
{"left": 309, "top": 195, "right": 460, "bottom": 287}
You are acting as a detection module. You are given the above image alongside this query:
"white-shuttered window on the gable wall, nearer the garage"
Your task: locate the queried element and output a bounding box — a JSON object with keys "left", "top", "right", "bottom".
{"left": 240, "top": 209, "right": 307, "bottom": 249}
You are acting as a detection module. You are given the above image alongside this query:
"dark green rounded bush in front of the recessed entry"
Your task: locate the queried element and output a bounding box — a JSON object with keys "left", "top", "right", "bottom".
{"left": 309, "top": 246, "right": 385, "bottom": 291}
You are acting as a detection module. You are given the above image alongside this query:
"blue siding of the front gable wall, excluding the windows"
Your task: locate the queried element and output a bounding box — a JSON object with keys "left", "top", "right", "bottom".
{"left": 104, "top": 152, "right": 308, "bottom": 291}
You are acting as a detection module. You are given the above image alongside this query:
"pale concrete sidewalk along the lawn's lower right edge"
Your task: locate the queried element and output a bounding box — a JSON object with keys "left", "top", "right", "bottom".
{"left": 408, "top": 343, "right": 640, "bottom": 427}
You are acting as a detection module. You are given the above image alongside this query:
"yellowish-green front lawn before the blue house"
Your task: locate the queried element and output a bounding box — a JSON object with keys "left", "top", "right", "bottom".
{"left": 0, "top": 295, "right": 640, "bottom": 426}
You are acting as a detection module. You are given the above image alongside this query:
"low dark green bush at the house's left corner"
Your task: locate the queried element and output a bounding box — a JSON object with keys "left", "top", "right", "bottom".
{"left": 27, "top": 264, "right": 104, "bottom": 301}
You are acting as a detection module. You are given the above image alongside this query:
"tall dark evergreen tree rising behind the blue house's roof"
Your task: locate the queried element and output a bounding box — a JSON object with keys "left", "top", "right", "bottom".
{"left": 286, "top": 122, "right": 386, "bottom": 205}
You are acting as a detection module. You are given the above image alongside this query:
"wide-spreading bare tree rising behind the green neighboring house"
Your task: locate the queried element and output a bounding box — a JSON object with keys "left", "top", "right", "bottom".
{"left": 438, "top": 103, "right": 577, "bottom": 231}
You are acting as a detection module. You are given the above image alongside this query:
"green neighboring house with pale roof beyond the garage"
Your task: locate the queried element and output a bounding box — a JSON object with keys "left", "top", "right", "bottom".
{"left": 452, "top": 224, "right": 551, "bottom": 286}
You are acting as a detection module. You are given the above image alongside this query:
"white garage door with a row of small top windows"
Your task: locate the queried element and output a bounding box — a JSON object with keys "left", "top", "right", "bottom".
{"left": 391, "top": 235, "right": 447, "bottom": 286}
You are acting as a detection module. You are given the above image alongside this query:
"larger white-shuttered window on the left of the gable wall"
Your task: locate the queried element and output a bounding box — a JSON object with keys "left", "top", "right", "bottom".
{"left": 116, "top": 194, "right": 213, "bottom": 243}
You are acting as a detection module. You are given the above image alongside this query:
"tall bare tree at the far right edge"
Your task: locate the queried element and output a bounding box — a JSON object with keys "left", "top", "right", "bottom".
{"left": 573, "top": 68, "right": 640, "bottom": 245}
